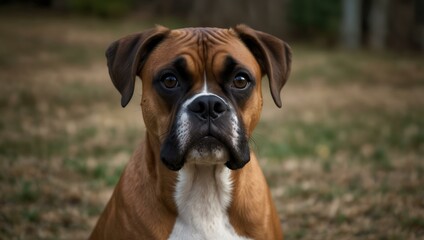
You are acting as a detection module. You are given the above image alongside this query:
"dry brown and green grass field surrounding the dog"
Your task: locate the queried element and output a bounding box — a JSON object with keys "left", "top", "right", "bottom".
{"left": 0, "top": 7, "right": 424, "bottom": 239}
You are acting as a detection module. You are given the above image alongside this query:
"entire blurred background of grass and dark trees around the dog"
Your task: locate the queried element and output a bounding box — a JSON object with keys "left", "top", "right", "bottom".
{"left": 0, "top": 0, "right": 424, "bottom": 239}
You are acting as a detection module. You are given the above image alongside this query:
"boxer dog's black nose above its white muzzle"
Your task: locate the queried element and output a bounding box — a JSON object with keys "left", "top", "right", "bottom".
{"left": 188, "top": 95, "right": 228, "bottom": 120}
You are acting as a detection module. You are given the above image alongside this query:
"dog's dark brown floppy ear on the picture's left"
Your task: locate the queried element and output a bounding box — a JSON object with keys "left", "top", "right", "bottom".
{"left": 106, "top": 26, "right": 170, "bottom": 107}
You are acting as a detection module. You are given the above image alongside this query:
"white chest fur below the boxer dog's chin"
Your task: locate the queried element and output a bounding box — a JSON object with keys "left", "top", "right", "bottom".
{"left": 169, "top": 164, "right": 246, "bottom": 239}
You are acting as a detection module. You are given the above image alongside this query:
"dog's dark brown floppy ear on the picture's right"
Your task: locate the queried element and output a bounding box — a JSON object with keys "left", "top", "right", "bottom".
{"left": 233, "top": 25, "right": 291, "bottom": 107}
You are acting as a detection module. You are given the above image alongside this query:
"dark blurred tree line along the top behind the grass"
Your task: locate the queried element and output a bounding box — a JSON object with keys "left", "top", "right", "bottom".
{"left": 0, "top": 0, "right": 424, "bottom": 50}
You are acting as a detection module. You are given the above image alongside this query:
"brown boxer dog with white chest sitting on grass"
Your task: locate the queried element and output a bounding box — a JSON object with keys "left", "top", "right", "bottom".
{"left": 90, "top": 25, "right": 291, "bottom": 239}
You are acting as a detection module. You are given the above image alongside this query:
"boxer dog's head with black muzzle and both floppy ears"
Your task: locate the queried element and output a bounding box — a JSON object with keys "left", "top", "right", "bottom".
{"left": 106, "top": 25, "right": 291, "bottom": 170}
